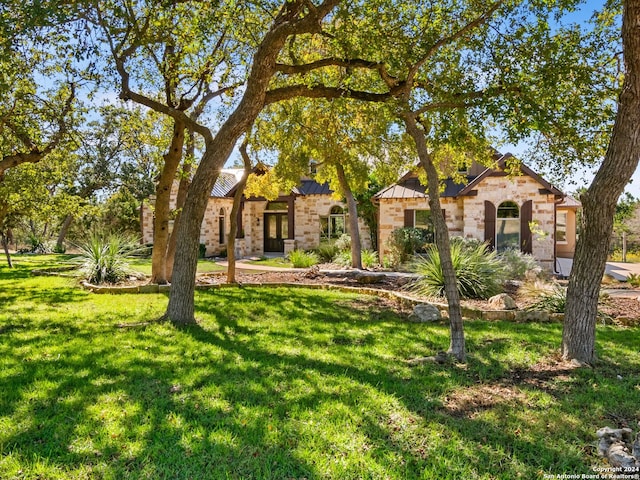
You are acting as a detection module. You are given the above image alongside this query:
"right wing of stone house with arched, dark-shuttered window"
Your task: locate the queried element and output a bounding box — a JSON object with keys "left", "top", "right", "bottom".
{"left": 374, "top": 154, "right": 580, "bottom": 272}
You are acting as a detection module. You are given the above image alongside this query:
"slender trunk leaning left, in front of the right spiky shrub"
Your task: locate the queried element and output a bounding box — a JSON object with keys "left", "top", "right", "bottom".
{"left": 403, "top": 114, "right": 466, "bottom": 362}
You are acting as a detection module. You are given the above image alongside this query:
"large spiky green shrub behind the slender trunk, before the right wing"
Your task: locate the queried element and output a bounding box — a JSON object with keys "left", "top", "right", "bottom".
{"left": 413, "top": 239, "right": 504, "bottom": 299}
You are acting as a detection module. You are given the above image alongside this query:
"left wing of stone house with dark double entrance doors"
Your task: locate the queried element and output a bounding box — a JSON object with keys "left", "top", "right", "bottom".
{"left": 141, "top": 165, "right": 371, "bottom": 257}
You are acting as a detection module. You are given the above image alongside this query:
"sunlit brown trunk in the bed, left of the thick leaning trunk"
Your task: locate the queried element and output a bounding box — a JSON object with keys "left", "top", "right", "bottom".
{"left": 151, "top": 119, "right": 185, "bottom": 284}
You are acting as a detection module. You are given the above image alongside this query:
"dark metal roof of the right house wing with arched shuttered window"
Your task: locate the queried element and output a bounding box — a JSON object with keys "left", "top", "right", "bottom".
{"left": 373, "top": 153, "right": 564, "bottom": 199}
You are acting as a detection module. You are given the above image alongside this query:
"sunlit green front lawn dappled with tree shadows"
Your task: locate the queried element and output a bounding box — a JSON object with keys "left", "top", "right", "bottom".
{"left": 0, "top": 257, "right": 640, "bottom": 479}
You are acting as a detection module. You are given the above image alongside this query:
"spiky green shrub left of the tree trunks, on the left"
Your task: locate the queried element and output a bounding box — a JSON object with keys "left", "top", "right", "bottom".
{"left": 72, "top": 233, "right": 140, "bottom": 284}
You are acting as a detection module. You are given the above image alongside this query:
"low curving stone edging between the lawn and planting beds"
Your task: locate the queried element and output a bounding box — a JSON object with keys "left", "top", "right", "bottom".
{"left": 81, "top": 282, "right": 564, "bottom": 322}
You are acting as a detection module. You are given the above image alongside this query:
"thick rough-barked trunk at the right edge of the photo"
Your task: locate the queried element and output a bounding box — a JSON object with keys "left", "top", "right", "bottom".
{"left": 562, "top": 0, "right": 640, "bottom": 364}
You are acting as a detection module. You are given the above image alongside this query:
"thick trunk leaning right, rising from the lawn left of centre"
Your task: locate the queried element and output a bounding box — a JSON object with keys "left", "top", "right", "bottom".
{"left": 165, "top": 0, "right": 324, "bottom": 324}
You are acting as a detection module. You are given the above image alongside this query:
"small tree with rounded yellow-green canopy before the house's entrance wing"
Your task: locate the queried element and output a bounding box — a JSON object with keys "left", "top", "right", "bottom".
{"left": 254, "top": 99, "right": 391, "bottom": 268}
